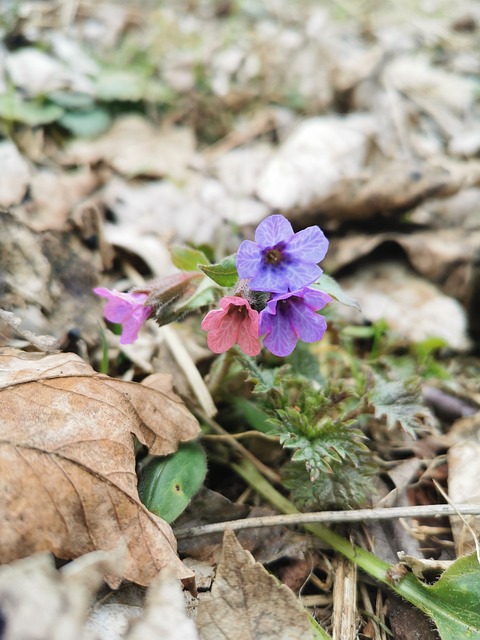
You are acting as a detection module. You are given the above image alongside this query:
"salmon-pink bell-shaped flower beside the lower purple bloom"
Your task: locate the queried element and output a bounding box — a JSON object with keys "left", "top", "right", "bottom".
{"left": 201, "top": 296, "right": 260, "bottom": 356}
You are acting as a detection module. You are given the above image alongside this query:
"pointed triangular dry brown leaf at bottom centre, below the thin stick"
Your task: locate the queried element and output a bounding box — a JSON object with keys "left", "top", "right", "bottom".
{"left": 197, "top": 529, "right": 312, "bottom": 640}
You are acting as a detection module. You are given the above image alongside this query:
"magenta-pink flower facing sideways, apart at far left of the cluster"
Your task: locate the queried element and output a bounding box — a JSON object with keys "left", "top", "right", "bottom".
{"left": 93, "top": 287, "right": 152, "bottom": 344}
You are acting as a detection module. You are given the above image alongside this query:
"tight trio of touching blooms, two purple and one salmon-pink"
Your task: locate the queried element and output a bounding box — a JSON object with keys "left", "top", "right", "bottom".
{"left": 202, "top": 215, "right": 331, "bottom": 356}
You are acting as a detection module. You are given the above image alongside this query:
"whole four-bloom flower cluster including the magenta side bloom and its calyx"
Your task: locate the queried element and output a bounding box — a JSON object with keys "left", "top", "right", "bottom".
{"left": 94, "top": 215, "right": 332, "bottom": 356}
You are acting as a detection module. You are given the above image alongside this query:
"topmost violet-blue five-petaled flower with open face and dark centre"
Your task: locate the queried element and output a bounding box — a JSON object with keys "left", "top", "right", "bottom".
{"left": 237, "top": 215, "right": 328, "bottom": 293}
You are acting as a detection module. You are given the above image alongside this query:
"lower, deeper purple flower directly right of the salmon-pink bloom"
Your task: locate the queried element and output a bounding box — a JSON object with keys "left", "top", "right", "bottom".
{"left": 260, "top": 287, "right": 332, "bottom": 356}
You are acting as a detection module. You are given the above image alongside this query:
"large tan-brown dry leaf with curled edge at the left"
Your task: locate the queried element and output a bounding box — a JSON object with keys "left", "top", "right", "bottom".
{"left": 0, "top": 349, "right": 199, "bottom": 585}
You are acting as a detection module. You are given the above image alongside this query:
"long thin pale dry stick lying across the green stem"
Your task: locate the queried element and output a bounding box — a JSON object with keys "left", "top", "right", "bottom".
{"left": 175, "top": 504, "right": 480, "bottom": 539}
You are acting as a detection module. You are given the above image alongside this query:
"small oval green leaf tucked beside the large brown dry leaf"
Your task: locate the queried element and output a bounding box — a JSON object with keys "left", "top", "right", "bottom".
{"left": 138, "top": 442, "right": 207, "bottom": 523}
